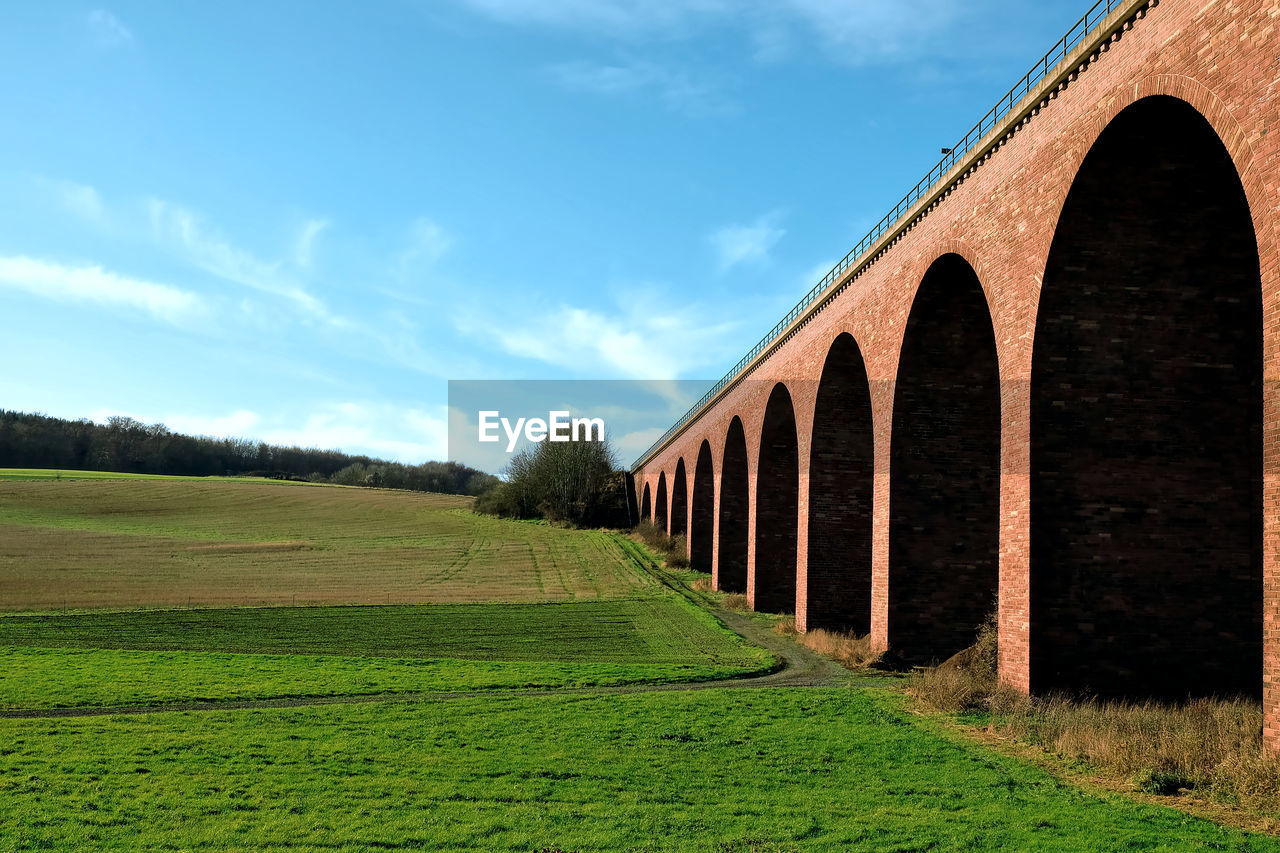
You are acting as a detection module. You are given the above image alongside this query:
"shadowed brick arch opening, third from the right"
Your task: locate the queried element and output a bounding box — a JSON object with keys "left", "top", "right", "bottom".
{"left": 804, "top": 332, "right": 876, "bottom": 634}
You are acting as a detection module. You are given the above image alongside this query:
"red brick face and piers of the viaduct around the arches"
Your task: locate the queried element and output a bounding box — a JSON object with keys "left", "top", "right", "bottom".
{"left": 636, "top": 0, "right": 1280, "bottom": 747}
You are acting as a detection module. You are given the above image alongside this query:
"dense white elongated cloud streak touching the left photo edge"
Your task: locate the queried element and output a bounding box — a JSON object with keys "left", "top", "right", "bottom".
{"left": 0, "top": 255, "right": 206, "bottom": 325}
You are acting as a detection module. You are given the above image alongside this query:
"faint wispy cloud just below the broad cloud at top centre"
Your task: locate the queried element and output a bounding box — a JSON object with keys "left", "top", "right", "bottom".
{"left": 544, "top": 60, "right": 731, "bottom": 115}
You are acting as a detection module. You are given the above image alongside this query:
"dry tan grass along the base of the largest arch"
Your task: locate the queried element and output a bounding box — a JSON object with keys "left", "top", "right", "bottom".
{"left": 910, "top": 607, "right": 1280, "bottom": 812}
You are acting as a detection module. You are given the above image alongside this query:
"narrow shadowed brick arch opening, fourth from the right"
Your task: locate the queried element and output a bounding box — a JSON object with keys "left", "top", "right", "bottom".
{"left": 749, "top": 382, "right": 800, "bottom": 612}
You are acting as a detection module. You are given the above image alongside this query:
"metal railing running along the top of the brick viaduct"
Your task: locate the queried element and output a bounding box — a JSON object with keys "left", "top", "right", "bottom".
{"left": 631, "top": 0, "right": 1126, "bottom": 469}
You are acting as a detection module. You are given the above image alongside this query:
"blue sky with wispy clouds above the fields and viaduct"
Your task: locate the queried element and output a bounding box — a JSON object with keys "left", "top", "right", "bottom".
{"left": 0, "top": 0, "right": 1085, "bottom": 462}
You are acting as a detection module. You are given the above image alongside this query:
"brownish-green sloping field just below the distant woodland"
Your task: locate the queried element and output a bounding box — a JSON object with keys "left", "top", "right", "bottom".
{"left": 0, "top": 476, "right": 653, "bottom": 610}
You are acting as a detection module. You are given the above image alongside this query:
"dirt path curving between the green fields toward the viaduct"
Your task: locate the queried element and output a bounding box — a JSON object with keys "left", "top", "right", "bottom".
{"left": 0, "top": 604, "right": 854, "bottom": 720}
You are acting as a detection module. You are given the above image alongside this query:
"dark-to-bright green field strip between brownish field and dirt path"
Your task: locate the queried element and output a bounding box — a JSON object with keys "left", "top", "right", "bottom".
{"left": 0, "top": 594, "right": 773, "bottom": 708}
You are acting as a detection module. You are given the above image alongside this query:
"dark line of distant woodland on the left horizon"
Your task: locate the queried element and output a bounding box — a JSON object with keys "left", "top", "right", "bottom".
{"left": 0, "top": 410, "right": 498, "bottom": 494}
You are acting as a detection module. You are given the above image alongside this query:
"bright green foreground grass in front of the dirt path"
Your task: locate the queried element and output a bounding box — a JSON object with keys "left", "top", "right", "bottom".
{"left": 0, "top": 689, "right": 1280, "bottom": 850}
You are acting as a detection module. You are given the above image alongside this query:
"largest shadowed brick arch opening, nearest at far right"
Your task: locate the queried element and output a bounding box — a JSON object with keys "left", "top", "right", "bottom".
{"left": 1029, "top": 91, "right": 1267, "bottom": 698}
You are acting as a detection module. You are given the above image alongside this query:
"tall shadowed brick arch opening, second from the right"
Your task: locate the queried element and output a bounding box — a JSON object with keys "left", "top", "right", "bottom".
{"left": 887, "top": 254, "right": 1001, "bottom": 661}
